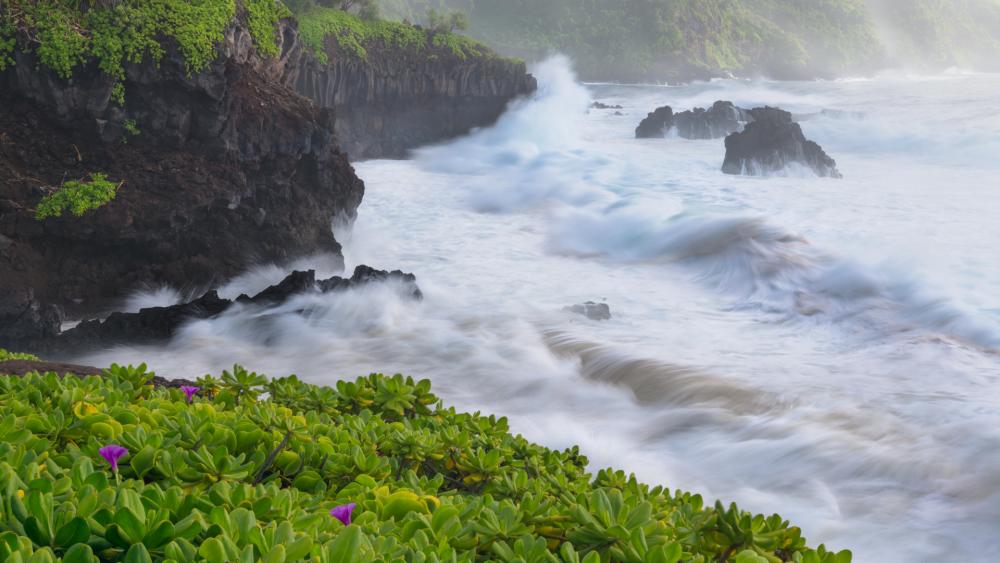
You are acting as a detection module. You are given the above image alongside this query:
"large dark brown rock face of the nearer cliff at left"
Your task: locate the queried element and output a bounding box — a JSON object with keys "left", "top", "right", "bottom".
{"left": 0, "top": 20, "right": 364, "bottom": 347}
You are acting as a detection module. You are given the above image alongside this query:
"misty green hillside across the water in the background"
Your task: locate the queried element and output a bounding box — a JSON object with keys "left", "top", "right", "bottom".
{"left": 383, "top": 0, "right": 1000, "bottom": 81}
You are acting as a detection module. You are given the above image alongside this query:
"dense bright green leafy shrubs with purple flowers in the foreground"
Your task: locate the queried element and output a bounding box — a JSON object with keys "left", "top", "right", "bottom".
{"left": 0, "top": 360, "right": 851, "bottom": 563}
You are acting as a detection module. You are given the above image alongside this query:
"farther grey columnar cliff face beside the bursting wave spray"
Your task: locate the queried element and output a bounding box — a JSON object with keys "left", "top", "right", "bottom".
{"left": 285, "top": 39, "right": 537, "bottom": 159}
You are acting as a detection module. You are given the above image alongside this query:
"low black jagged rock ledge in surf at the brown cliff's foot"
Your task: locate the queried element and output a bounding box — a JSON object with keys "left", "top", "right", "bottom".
{"left": 31, "top": 266, "right": 423, "bottom": 355}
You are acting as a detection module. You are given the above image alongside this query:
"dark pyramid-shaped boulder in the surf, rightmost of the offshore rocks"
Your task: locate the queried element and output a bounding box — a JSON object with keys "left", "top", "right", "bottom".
{"left": 722, "top": 108, "right": 841, "bottom": 178}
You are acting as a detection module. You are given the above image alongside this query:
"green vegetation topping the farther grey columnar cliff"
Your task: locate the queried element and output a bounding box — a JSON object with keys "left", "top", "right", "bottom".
{"left": 296, "top": 8, "right": 496, "bottom": 63}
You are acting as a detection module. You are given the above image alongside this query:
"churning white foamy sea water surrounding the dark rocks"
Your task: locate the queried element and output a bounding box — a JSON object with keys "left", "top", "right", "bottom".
{"left": 78, "top": 59, "right": 1000, "bottom": 562}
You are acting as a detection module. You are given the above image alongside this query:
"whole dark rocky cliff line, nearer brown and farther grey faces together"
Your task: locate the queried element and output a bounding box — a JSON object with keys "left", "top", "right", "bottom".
{"left": 0, "top": 16, "right": 535, "bottom": 348}
